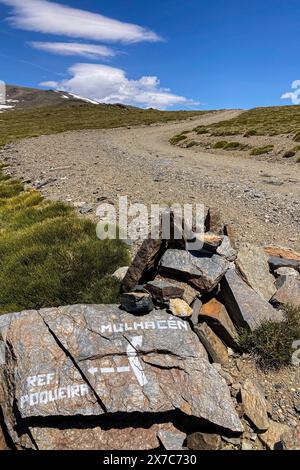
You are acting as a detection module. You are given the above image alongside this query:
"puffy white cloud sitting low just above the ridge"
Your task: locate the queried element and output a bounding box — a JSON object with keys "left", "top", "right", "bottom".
{"left": 41, "top": 63, "right": 199, "bottom": 109}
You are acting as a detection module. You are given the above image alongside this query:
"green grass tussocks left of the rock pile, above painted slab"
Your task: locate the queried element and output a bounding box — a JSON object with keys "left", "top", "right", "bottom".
{"left": 0, "top": 168, "right": 129, "bottom": 314}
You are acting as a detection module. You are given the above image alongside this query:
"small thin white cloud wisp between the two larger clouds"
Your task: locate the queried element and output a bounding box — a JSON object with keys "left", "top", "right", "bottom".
{"left": 30, "top": 41, "right": 115, "bottom": 59}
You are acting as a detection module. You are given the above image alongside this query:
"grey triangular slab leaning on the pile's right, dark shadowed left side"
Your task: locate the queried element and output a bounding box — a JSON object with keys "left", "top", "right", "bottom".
{"left": 221, "top": 269, "right": 284, "bottom": 331}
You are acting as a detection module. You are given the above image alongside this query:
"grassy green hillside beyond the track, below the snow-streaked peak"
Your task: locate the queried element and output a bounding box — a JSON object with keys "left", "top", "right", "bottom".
{"left": 0, "top": 103, "right": 208, "bottom": 147}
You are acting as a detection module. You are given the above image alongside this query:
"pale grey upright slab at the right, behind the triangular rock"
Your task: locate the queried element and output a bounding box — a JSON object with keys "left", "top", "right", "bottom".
{"left": 236, "top": 243, "right": 276, "bottom": 301}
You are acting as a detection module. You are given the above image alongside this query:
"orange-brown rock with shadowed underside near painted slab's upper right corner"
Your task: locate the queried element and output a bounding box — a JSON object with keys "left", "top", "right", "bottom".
{"left": 200, "top": 299, "right": 238, "bottom": 348}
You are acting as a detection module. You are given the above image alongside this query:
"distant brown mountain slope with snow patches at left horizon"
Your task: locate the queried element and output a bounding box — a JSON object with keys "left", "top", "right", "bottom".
{"left": 1, "top": 85, "right": 98, "bottom": 111}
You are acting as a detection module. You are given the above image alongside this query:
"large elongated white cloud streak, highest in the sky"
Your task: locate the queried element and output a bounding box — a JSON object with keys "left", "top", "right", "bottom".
{"left": 0, "top": 0, "right": 160, "bottom": 43}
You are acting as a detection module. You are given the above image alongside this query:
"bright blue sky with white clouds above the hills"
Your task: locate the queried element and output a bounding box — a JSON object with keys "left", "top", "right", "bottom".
{"left": 0, "top": 0, "right": 300, "bottom": 109}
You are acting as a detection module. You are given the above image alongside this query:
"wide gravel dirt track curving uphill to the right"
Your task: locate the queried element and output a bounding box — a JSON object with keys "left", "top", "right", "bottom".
{"left": 1, "top": 111, "right": 300, "bottom": 249}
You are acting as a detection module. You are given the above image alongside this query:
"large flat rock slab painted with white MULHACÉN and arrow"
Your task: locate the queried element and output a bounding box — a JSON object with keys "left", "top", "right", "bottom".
{"left": 0, "top": 305, "right": 242, "bottom": 449}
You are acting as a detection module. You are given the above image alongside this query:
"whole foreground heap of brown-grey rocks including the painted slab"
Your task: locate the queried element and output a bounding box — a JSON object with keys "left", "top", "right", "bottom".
{"left": 0, "top": 210, "right": 300, "bottom": 450}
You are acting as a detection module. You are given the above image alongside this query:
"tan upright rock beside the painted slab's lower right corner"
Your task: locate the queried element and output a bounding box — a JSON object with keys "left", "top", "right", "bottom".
{"left": 241, "top": 379, "right": 270, "bottom": 432}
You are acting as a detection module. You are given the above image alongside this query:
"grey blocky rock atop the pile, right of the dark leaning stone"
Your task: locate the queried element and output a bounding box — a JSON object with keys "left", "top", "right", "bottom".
{"left": 160, "top": 250, "right": 229, "bottom": 293}
